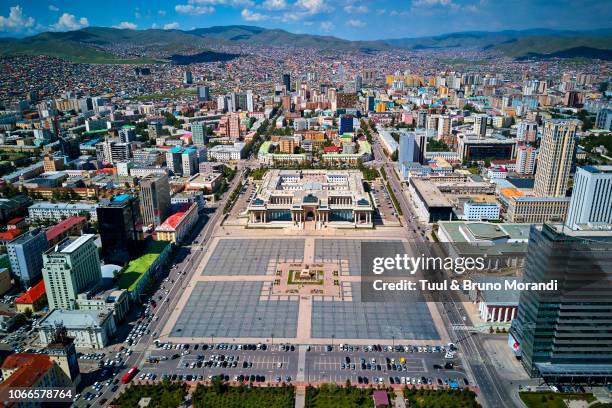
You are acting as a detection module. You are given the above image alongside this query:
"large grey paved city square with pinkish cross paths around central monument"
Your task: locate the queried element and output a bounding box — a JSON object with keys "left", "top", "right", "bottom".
{"left": 162, "top": 236, "right": 446, "bottom": 344}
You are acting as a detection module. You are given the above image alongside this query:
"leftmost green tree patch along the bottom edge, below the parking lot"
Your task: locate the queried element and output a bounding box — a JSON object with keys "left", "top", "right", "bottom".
{"left": 112, "top": 382, "right": 187, "bottom": 408}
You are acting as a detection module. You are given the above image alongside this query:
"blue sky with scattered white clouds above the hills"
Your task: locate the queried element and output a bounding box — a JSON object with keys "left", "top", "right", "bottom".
{"left": 0, "top": 0, "right": 612, "bottom": 40}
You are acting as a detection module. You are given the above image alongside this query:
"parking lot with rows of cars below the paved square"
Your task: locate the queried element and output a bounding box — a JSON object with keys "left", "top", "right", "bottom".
{"left": 138, "top": 344, "right": 467, "bottom": 388}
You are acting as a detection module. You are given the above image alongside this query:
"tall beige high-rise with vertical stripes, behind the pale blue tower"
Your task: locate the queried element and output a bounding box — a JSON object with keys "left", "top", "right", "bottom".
{"left": 533, "top": 119, "right": 579, "bottom": 197}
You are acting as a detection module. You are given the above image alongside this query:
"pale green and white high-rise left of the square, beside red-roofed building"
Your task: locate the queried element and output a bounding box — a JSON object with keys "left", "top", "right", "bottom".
{"left": 42, "top": 234, "right": 102, "bottom": 310}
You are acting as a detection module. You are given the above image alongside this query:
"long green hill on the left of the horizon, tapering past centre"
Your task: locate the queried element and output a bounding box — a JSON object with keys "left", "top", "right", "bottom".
{"left": 0, "top": 26, "right": 392, "bottom": 63}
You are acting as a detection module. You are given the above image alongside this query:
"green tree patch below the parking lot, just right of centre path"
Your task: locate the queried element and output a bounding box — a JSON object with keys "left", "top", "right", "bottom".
{"left": 306, "top": 384, "right": 374, "bottom": 408}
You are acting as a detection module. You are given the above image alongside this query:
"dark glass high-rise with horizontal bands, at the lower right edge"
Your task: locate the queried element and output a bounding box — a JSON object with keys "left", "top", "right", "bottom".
{"left": 511, "top": 224, "right": 612, "bottom": 383}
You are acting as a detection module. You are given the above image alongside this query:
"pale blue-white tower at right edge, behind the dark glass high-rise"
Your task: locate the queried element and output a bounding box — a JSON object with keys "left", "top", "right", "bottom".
{"left": 566, "top": 166, "right": 612, "bottom": 229}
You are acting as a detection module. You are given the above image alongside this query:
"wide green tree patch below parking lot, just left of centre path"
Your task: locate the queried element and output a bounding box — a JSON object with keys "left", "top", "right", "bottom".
{"left": 191, "top": 383, "right": 294, "bottom": 408}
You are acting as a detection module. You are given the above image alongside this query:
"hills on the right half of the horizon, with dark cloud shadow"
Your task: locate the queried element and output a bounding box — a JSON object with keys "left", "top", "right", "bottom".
{"left": 383, "top": 29, "right": 612, "bottom": 58}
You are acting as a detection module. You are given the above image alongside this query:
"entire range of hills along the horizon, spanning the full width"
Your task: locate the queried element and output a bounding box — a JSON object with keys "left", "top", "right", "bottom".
{"left": 0, "top": 25, "right": 612, "bottom": 63}
